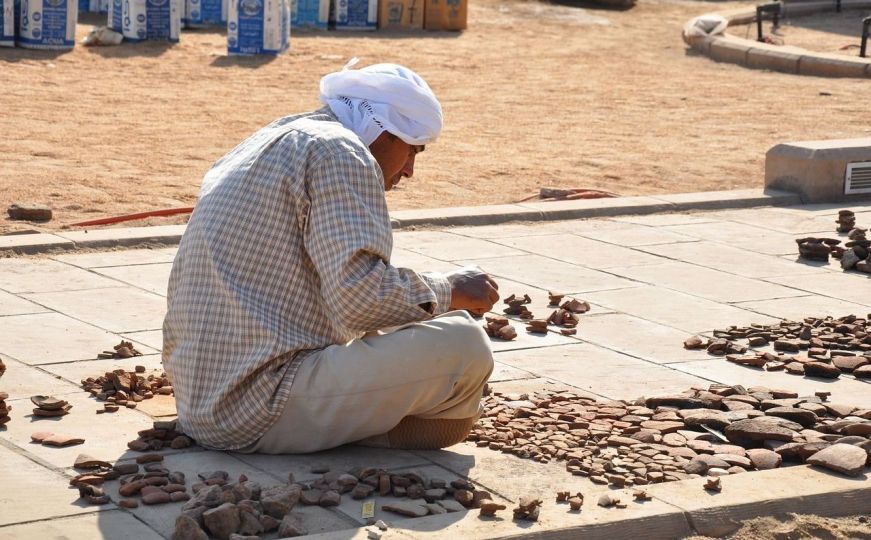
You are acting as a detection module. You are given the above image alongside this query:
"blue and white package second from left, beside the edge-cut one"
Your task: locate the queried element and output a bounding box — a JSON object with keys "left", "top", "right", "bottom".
{"left": 15, "top": 0, "right": 79, "bottom": 51}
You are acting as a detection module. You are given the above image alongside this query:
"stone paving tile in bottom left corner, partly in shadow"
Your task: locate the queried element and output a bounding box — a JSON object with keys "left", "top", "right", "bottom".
{"left": 0, "top": 510, "right": 163, "bottom": 540}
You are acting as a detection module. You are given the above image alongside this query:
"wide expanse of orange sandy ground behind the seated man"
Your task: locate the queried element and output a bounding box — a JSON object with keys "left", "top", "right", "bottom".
{"left": 0, "top": 0, "right": 871, "bottom": 232}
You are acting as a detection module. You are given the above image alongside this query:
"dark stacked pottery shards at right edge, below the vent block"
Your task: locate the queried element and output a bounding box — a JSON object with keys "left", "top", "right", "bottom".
{"left": 796, "top": 210, "right": 871, "bottom": 273}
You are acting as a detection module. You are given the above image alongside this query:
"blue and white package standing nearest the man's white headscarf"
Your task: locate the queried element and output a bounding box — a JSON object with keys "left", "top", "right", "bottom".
{"left": 227, "top": 0, "right": 290, "bottom": 55}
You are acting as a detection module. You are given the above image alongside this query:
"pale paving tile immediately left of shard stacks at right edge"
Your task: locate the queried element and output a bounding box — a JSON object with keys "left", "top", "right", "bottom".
{"left": 665, "top": 221, "right": 816, "bottom": 255}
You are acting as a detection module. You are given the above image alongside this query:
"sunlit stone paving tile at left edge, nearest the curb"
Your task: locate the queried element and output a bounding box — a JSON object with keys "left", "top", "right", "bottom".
{"left": 0, "top": 258, "right": 121, "bottom": 293}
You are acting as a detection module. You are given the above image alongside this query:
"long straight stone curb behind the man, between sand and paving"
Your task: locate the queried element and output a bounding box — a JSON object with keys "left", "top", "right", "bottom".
{"left": 0, "top": 189, "right": 801, "bottom": 255}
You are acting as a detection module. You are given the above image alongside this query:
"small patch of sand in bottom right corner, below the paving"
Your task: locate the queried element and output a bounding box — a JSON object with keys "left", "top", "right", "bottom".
{"left": 684, "top": 515, "right": 871, "bottom": 540}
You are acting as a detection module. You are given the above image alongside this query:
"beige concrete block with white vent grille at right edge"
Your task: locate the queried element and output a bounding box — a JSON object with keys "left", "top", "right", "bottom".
{"left": 765, "top": 138, "right": 871, "bottom": 203}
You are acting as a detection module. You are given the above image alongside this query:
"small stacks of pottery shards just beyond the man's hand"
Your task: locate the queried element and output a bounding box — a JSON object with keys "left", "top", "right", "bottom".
{"left": 484, "top": 291, "right": 590, "bottom": 341}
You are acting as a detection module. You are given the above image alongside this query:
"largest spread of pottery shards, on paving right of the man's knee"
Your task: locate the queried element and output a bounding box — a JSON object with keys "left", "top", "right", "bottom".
{"left": 467, "top": 384, "right": 871, "bottom": 487}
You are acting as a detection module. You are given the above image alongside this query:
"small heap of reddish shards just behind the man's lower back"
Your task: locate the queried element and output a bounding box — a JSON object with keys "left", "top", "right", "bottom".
{"left": 82, "top": 366, "right": 173, "bottom": 413}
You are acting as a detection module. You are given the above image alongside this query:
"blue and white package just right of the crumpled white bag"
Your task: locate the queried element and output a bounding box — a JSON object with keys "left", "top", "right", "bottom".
{"left": 122, "top": 0, "right": 184, "bottom": 43}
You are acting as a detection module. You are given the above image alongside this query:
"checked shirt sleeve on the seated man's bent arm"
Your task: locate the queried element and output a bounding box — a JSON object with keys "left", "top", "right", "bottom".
{"left": 305, "top": 151, "right": 450, "bottom": 332}
